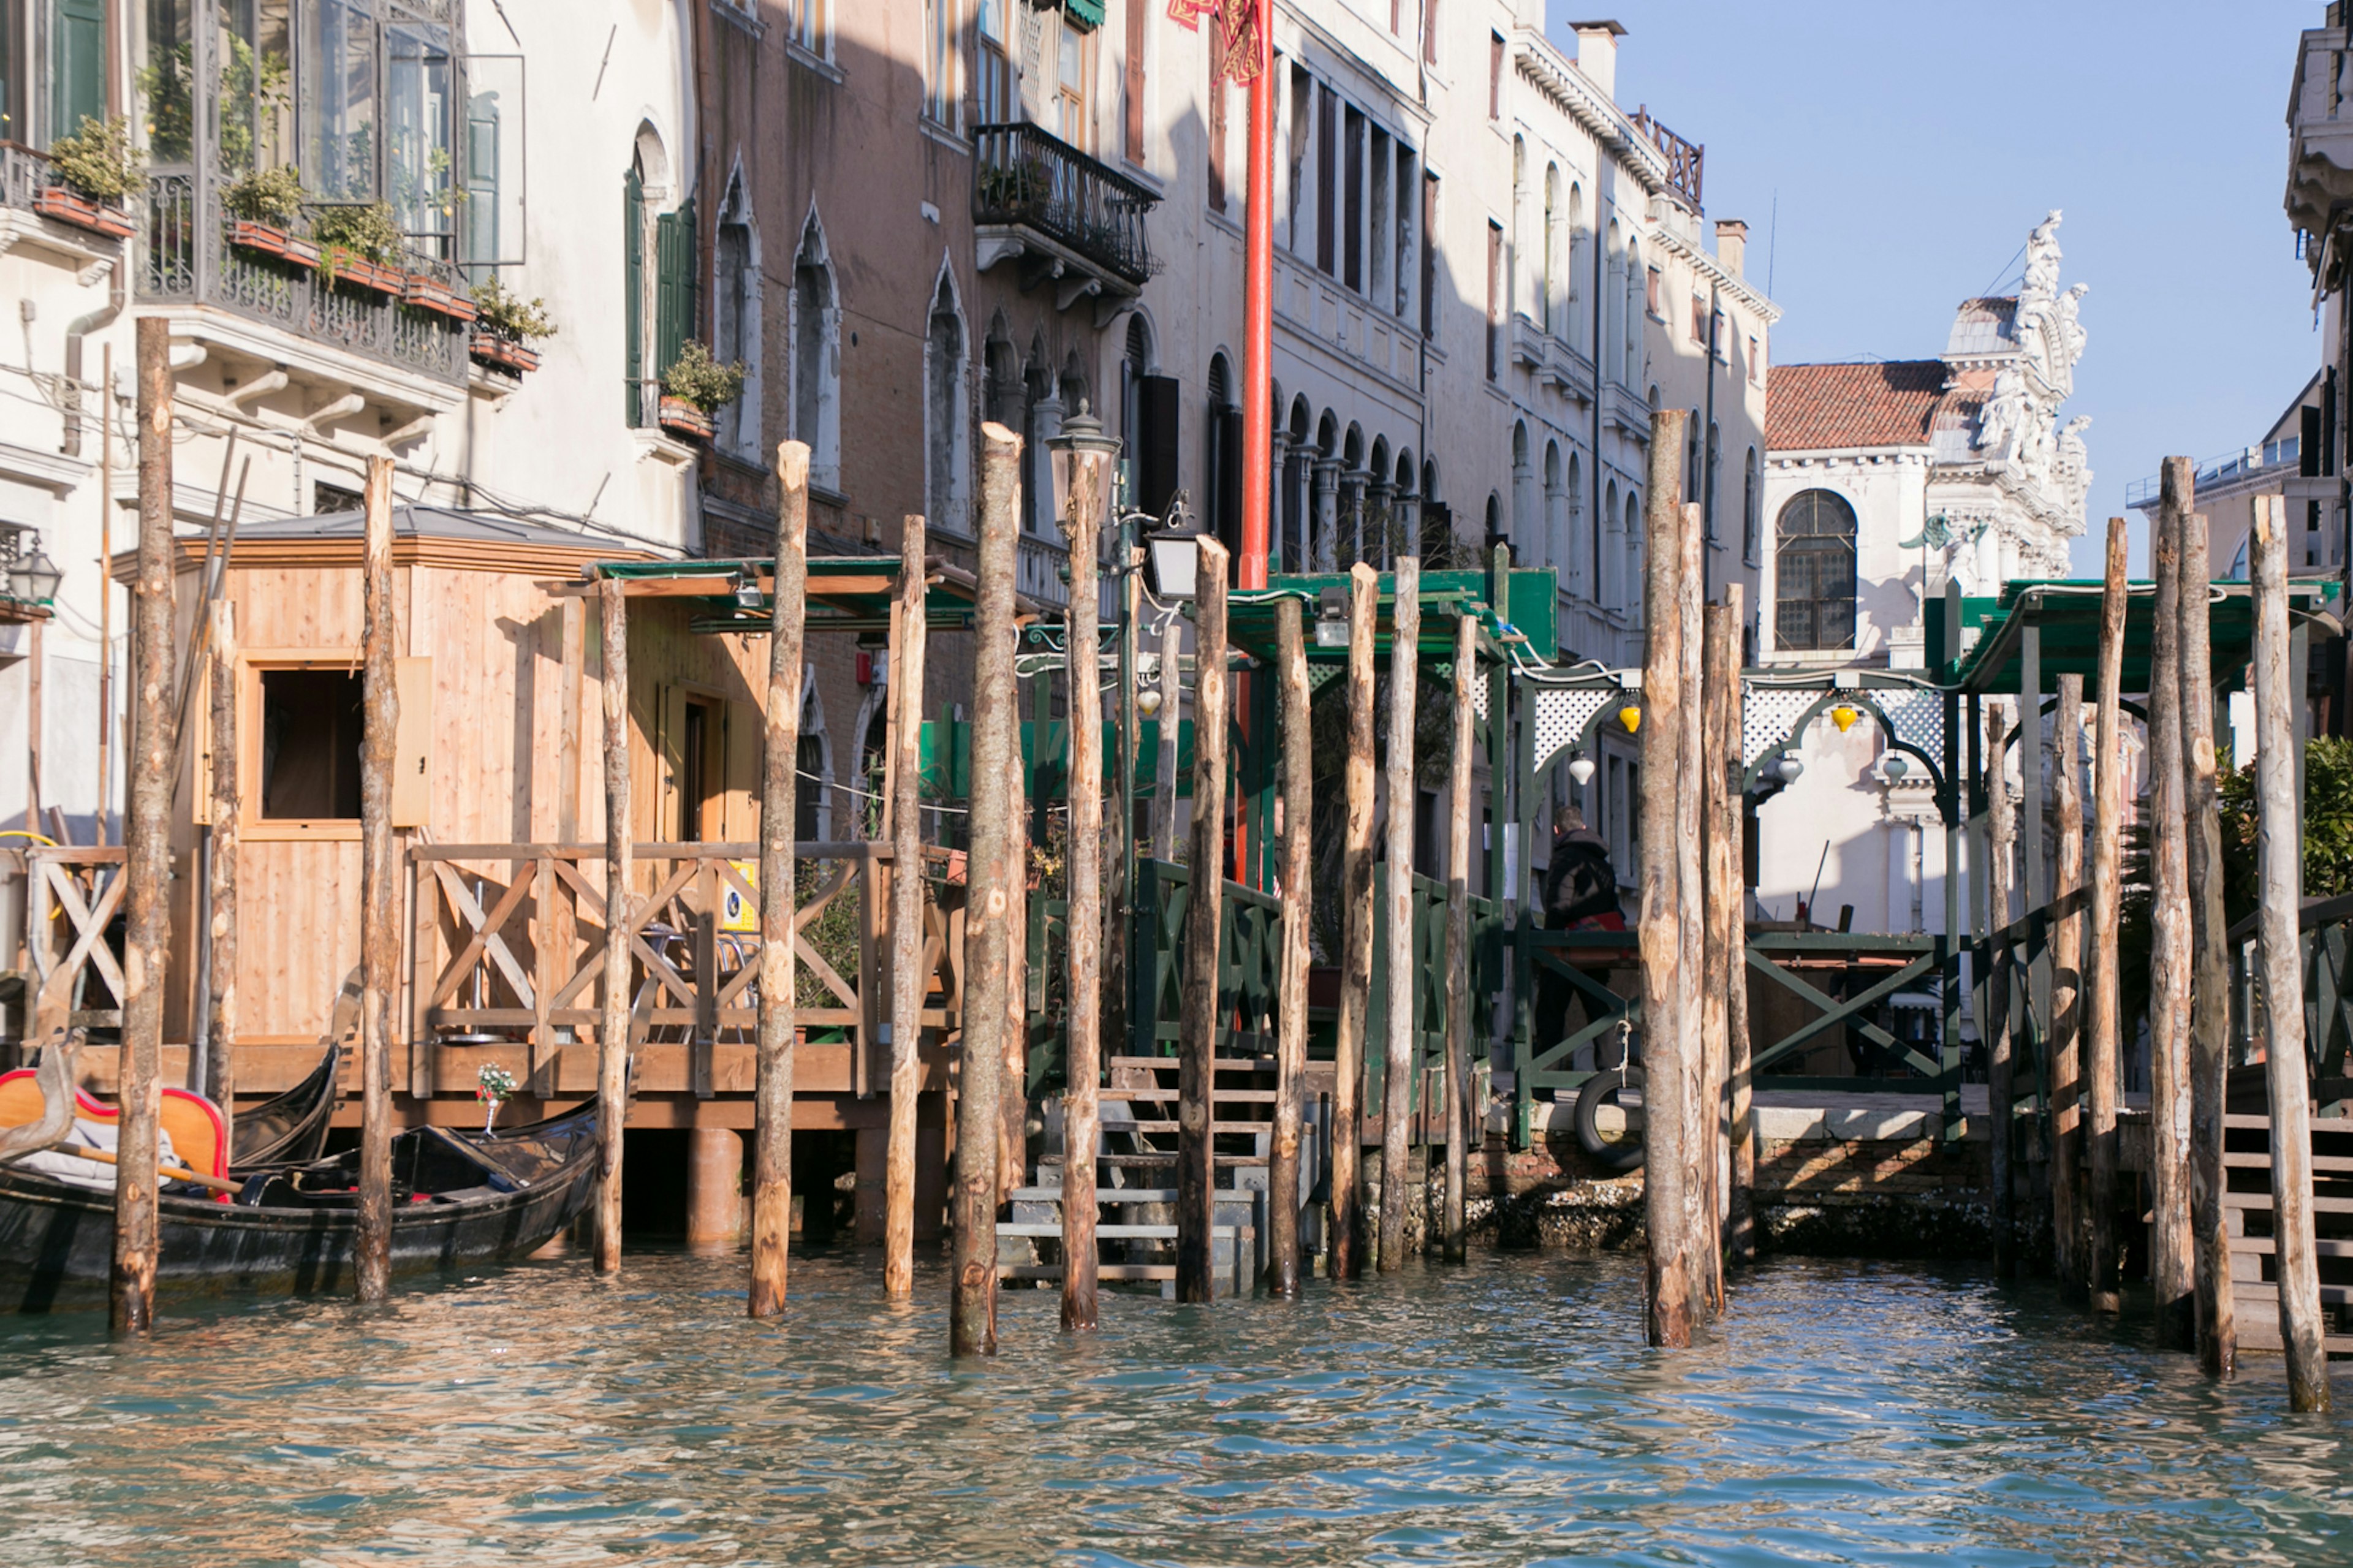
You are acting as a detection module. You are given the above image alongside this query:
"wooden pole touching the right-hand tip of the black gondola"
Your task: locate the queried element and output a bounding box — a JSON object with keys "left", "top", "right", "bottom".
{"left": 596, "top": 577, "right": 638, "bottom": 1274}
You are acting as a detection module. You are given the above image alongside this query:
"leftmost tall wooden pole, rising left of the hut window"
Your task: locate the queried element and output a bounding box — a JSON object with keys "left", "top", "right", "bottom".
{"left": 99, "top": 316, "right": 174, "bottom": 1335}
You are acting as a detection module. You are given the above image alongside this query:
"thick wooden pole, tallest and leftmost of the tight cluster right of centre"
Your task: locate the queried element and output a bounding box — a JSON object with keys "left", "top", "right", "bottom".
{"left": 1635, "top": 410, "right": 1692, "bottom": 1349}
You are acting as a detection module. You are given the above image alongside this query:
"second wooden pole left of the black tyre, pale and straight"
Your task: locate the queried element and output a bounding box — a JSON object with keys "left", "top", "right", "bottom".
{"left": 1374, "top": 556, "right": 1421, "bottom": 1274}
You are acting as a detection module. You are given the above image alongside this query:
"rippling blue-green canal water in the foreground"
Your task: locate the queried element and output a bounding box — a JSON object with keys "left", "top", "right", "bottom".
{"left": 0, "top": 1252, "right": 2353, "bottom": 1568}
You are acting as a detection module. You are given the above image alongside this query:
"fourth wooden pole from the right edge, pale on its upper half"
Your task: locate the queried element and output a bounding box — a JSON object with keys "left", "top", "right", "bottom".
{"left": 2085, "top": 518, "right": 2127, "bottom": 1311}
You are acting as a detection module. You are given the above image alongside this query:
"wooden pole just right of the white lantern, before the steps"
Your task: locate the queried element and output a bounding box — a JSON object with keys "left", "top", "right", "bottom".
{"left": 1176, "top": 534, "right": 1228, "bottom": 1302}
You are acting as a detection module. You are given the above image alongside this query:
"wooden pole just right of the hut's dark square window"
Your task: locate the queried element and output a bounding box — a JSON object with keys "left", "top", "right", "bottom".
{"left": 350, "top": 456, "right": 400, "bottom": 1302}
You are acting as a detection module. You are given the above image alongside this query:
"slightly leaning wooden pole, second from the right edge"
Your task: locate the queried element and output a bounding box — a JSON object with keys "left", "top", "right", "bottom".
{"left": 2181, "top": 513, "right": 2238, "bottom": 1377}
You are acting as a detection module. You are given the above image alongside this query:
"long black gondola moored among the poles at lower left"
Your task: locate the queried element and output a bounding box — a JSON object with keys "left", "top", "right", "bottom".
{"left": 0, "top": 1104, "right": 597, "bottom": 1311}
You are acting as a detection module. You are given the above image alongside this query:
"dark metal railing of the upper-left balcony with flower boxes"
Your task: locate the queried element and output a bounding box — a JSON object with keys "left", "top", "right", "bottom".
{"left": 139, "top": 167, "right": 468, "bottom": 384}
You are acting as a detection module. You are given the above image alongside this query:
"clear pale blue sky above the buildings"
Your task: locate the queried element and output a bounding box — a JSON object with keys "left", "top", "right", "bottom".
{"left": 1548, "top": 0, "right": 2322, "bottom": 575}
